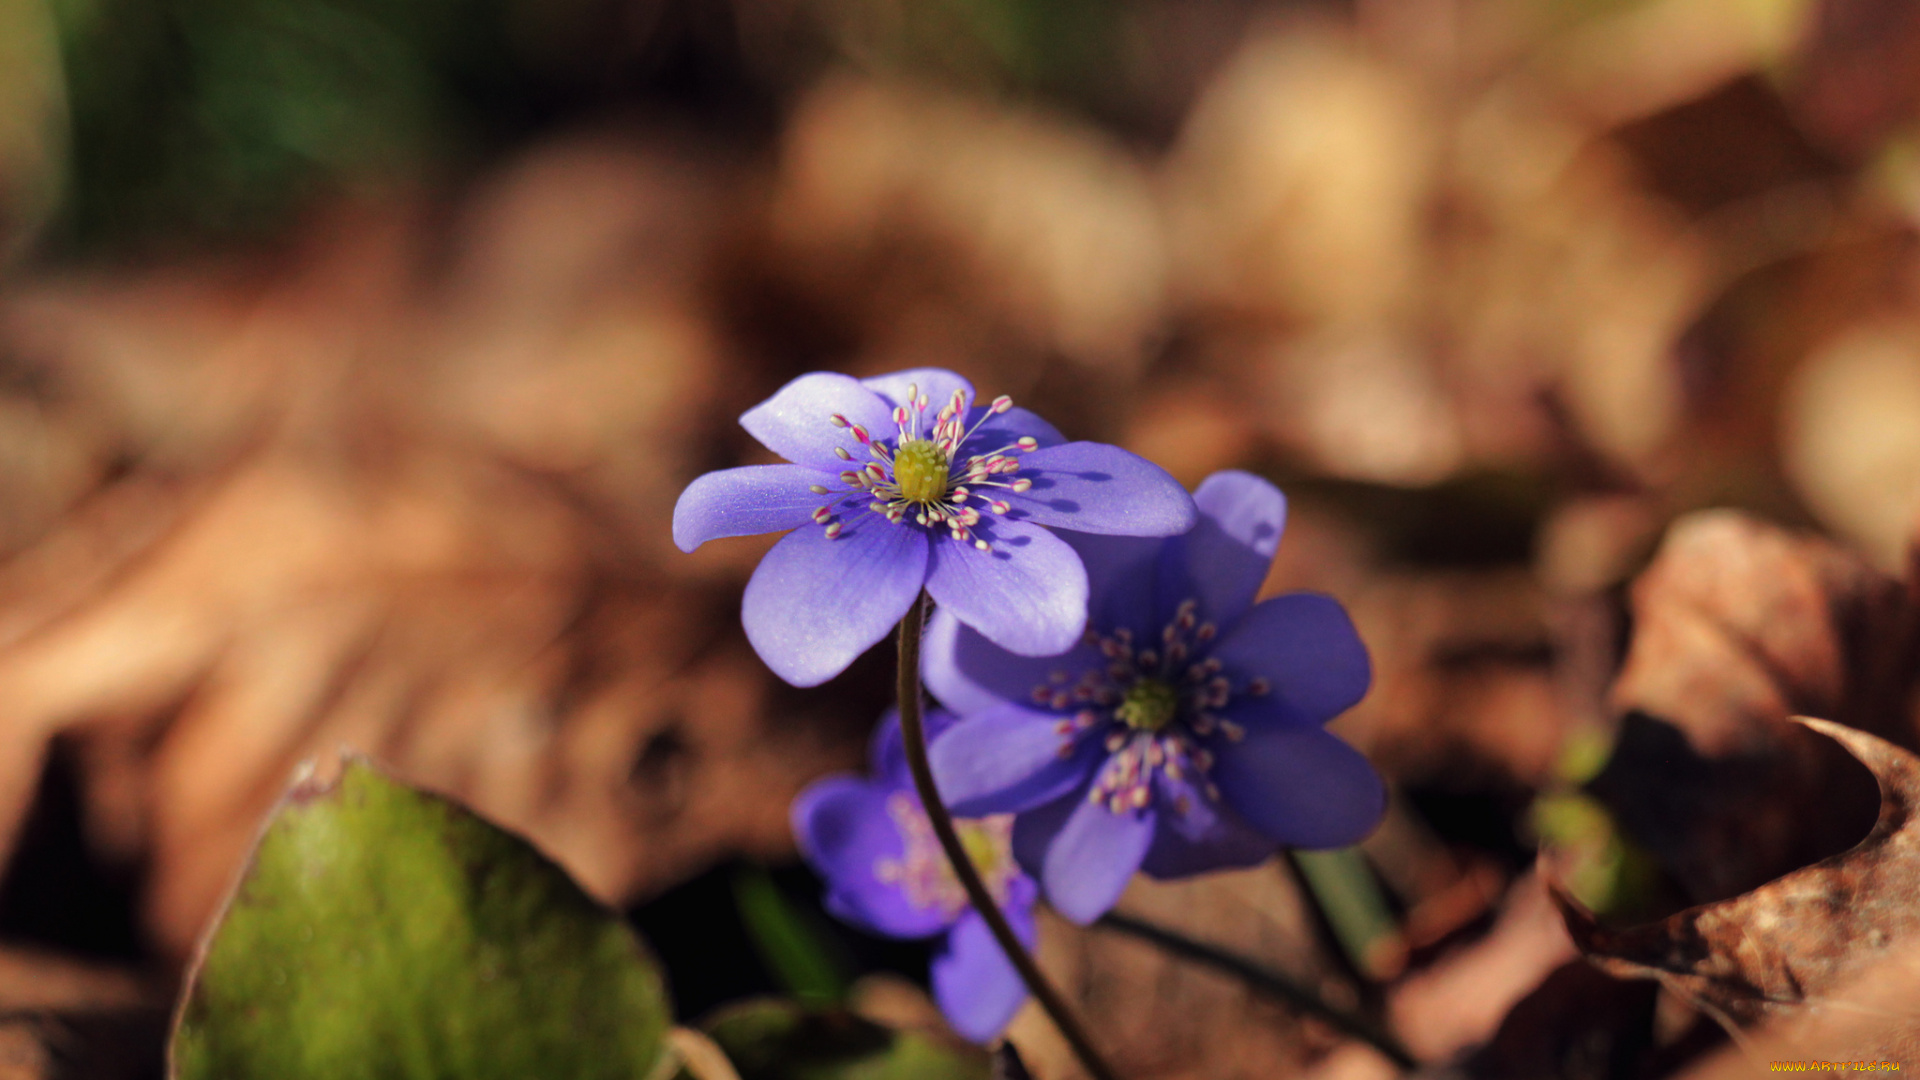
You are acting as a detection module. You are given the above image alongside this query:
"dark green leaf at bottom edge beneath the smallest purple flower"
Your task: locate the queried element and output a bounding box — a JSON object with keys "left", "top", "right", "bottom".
{"left": 705, "top": 997, "right": 989, "bottom": 1080}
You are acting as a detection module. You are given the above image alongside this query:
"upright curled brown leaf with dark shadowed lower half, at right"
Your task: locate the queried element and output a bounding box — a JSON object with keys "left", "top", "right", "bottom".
{"left": 1592, "top": 511, "right": 1914, "bottom": 903}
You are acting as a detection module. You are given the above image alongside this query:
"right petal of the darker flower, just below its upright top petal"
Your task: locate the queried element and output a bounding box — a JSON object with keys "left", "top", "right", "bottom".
{"left": 1213, "top": 592, "right": 1373, "bottom": 723}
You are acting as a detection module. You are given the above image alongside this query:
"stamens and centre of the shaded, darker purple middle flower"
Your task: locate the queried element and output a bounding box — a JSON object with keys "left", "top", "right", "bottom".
{"left": 1033, "top": 600, "right": 1271, "bottom": 815}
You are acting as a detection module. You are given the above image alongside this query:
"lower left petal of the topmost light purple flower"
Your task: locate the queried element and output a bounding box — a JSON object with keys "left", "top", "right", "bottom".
{"left": 741, "top": 513, "right": 927, "bottom": 686}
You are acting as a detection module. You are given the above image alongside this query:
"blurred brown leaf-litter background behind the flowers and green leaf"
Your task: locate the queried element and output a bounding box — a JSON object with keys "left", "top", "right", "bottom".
{"left": 0, "top": 0, "right": 1920, "bottom": 1080}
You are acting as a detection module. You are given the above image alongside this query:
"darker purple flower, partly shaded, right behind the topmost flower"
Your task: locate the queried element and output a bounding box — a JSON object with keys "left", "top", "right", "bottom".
{"left": 925, "top": 473, "right": 1384, "bottom": 922}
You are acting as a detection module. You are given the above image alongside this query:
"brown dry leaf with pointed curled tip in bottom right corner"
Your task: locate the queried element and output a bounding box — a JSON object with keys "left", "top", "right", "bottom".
{"left": 1553, "top": 717, "right": 1920, "bottom": 1026}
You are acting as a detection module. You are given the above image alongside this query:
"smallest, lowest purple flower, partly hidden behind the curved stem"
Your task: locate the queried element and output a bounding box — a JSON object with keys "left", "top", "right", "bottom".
{"left": 793, "top": 711, "right": 1039, "bottom": 1043}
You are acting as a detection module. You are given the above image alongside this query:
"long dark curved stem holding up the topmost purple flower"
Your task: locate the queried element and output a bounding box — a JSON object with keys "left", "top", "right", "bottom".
{"left": 899, "top": 592, "right": 1119, "bottom": 1080}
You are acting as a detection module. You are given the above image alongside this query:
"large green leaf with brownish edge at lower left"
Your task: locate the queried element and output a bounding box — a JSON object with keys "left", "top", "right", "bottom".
{"left": 171, "top": 761, "right": 670, "bottom": 1080}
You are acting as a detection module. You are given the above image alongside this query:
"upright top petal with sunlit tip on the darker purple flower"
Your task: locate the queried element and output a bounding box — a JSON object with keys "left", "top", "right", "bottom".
{"left": 1160, "top": 469, "right": 1286, "bottom": 626}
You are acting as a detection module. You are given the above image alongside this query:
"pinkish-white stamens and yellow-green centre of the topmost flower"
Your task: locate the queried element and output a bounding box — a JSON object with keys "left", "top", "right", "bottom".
{"left": 810, "top": 384, "right": 1041, "bottom": 552}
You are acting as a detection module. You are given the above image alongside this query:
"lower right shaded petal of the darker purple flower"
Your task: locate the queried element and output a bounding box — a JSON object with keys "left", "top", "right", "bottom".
{"left": 1212, "top": 721, "right": 1386, "bottom": 847}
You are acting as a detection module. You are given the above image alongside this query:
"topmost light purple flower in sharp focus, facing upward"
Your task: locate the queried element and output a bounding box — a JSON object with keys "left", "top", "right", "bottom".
{"left": 674, "top": 369, "right": 1194, "bottom": 686}
